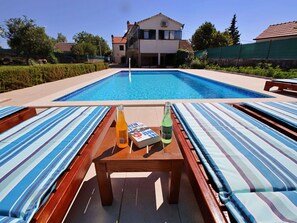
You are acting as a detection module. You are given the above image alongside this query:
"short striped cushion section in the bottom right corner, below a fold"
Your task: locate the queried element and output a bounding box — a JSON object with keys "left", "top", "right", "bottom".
{"left": 226, "top": 191, "right": 297, "bottom": 223}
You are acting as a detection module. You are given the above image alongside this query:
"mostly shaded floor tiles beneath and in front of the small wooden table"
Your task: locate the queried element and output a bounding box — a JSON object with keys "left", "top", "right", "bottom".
{"left": 64, "top": 167, "right": 204, "bottom": 223}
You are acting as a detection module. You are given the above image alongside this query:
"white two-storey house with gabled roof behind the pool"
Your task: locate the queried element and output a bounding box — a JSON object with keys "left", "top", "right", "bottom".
{"left": 125, "top": 13, "right": 184, "bottom": 67}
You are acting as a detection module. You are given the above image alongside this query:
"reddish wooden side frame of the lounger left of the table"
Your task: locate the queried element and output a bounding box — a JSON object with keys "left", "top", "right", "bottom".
{"left": 31, "top": 107, "right": 116, "bottom": 222}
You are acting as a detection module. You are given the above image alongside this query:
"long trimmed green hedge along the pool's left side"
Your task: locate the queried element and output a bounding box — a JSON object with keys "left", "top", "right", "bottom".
{"left": 0, "top": 62, "right": 108, "bottom": 93}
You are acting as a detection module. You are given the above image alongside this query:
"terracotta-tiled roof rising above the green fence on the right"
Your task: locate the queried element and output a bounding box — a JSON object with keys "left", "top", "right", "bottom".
{"left": 254, "top": 21, "right": 297, "bottom": 42}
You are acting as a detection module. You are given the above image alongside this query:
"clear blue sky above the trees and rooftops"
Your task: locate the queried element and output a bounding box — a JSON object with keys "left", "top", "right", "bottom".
{"left": 0, "top": 0, "right": 297, "bottom": 48}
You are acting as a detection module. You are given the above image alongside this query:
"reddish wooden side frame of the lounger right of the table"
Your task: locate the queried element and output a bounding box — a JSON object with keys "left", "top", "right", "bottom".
{"left": 171, "top": 112, "right": 230, "bottom": 223}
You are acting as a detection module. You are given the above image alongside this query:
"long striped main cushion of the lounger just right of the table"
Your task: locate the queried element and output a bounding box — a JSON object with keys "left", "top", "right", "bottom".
{"left": 173, "top": 103, "right": 297, "bottom": 201}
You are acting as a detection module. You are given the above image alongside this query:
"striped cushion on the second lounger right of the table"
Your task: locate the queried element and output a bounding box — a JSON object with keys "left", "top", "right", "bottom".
{"left": 242, "top": 102, "right": 297, "bottom": 131}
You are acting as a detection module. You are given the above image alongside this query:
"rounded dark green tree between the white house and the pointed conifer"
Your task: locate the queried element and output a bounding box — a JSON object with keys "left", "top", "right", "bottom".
{"left": 191, "top": 22, "right": 231, "bottom": 50}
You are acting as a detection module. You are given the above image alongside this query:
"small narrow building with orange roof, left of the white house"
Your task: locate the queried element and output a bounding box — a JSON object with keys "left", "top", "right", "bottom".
{"left": 111, "top": 35, "right": 127, "bottom": 64}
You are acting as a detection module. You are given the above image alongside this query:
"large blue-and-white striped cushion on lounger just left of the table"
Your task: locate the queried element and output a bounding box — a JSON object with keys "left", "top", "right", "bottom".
{"left": 0, "top": 107, "right": 109, "bottom": 222}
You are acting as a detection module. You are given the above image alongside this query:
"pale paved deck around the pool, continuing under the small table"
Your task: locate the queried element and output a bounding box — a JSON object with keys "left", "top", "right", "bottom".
{"left": 0, "top": 69, "right": 297, "bottom": 223}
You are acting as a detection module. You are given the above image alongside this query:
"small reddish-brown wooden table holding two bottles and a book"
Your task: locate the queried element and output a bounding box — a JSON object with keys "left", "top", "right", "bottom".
{"left": 93, "top": 127, "right": 183, "bottom": 205}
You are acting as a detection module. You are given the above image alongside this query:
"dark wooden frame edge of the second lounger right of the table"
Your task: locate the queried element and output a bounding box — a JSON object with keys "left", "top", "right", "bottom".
{"left": 233, "top": 104, "right": 297, "bottom": 140}
